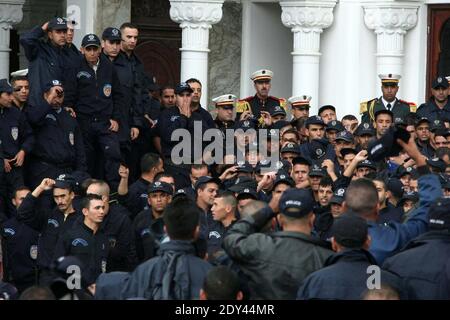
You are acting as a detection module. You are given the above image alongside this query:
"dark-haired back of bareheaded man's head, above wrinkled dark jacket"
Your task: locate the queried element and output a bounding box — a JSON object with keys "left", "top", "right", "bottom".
{"left": 163, "top": 197, "right": 201, "bottom": 240}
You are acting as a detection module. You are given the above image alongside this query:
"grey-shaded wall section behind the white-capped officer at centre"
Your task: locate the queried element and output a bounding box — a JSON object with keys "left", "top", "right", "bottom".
{"left": 240, "top": 1, "right": 293, "bottom": 99}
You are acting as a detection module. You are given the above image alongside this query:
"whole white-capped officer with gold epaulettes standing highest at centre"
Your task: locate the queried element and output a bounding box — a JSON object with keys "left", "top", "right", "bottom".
{"left": 236, "top": 69, "right": 286, "bottom": 126}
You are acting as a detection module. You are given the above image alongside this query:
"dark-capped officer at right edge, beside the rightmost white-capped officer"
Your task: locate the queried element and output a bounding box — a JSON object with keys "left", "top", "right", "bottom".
{"left": 417, "top": 76, "right": 450, "bottom": 123}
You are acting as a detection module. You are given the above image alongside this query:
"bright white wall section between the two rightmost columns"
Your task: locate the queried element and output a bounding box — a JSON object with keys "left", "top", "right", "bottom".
{"left": 319, "top": 0, "right": 380, "bottom": 119}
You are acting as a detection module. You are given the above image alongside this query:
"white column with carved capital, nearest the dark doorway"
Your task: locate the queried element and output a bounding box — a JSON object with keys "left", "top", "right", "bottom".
{"left": 170, "top": 0, "right": 224, "bottom": 108}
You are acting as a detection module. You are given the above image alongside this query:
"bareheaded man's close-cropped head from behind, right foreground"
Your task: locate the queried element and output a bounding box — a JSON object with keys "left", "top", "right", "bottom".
{"left": 343, "top": 178, "right": 379, "bottom": 220}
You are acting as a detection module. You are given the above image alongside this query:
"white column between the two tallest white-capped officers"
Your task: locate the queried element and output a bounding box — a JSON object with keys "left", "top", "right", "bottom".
{"left": 280, "top": 0, "right": 336, "bottom": 112}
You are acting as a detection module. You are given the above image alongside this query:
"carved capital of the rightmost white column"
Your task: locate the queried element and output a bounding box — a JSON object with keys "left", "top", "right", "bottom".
{"left": 363, "top": 1, "right": 420, "bottom": 34}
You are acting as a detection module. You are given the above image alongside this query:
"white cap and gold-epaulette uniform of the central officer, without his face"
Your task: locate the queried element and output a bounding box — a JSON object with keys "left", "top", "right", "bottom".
{"left": 236, "top": 69, "right": 286, "bottom": 126}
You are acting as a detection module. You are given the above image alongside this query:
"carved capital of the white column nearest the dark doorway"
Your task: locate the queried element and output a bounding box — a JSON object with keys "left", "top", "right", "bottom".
{"left": 170, "top": 0, "right": 224, "bottom": 28}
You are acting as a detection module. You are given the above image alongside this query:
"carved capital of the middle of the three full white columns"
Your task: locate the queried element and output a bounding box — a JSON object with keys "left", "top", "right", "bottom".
{"left": 280, "top": 0, "right": 336, "bottom": 33}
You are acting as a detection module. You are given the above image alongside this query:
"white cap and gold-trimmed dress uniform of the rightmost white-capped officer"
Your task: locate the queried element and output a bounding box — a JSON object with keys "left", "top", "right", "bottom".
{"left": 359, "top": 74, "right": 417, "bottom": 123}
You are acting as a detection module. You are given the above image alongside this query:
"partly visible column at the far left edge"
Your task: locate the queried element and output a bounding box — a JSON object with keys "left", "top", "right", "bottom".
{"left": 0, "top": 0, "right": 25, "bottom": 79}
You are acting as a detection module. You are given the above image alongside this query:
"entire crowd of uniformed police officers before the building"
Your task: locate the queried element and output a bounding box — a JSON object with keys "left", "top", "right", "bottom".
{"left": 0, "top": 18, "right": 450, "bottom": 299}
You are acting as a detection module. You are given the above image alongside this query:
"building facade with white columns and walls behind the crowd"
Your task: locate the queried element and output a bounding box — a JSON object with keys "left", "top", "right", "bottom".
{"left": 0, "top": 0, "right": 450, "bottom": 117}
